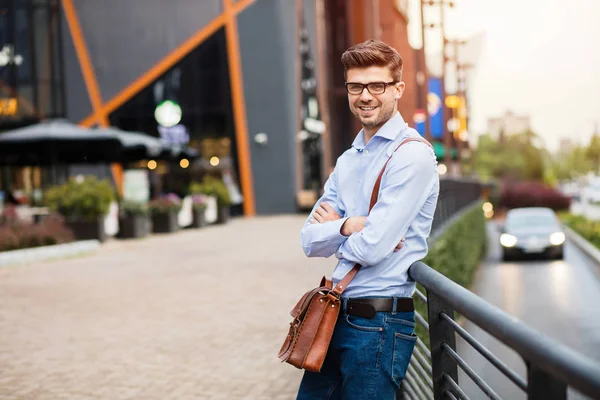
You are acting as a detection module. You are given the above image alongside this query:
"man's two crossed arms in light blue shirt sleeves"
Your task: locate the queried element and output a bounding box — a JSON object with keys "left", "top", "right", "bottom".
{"left": 301, "top": 143, "right": 438, "bottom": 265}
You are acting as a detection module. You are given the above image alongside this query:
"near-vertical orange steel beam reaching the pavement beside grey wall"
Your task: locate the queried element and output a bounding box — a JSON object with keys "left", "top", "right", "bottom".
{"left": 223, "top": 0, "right": 256, "bottom": 217}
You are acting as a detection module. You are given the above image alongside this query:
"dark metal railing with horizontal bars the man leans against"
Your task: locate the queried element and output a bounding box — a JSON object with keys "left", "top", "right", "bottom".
{"left": 398, "top": 261, "right": 600, "bottom": 400}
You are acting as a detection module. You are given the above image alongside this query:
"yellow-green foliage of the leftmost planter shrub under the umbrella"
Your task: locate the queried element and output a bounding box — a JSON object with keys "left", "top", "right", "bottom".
{"left": 46, "top": 176, "right": 115, "bottom": 221}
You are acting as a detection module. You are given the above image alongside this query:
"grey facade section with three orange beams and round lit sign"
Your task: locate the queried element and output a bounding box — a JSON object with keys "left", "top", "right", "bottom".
{"left": 62, "top": 0, "right": 326, "bottom": 215}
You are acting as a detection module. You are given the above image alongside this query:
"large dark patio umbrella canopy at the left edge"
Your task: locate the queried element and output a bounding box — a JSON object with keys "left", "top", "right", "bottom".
{"left": 0, "top": 119, "right": 124, "bottom": 165}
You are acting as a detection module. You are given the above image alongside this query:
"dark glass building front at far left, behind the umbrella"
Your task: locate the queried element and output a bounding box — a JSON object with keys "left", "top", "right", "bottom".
{"left": 0, "top": 0, "right": 66, "bottom": 203}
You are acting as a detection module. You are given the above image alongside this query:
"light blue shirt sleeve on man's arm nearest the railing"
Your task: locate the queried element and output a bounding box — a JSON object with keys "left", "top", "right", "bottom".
{"left": 335, "top": 142, "right": 439, "bottom": 266}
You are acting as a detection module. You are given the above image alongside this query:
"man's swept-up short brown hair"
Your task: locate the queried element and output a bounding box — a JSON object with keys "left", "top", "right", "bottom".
{"left": 342, "top": 40, "right": 402, "bottom": 81}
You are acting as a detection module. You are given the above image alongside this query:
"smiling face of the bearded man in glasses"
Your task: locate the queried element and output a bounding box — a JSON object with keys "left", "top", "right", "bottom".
{"left": 346, "top": 67, "right": 404, "bottom": 130}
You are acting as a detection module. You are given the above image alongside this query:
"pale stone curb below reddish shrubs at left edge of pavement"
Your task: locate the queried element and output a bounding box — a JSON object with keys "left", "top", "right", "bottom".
{"left": 0, "top": 240, "right": 100, "bottom": 267}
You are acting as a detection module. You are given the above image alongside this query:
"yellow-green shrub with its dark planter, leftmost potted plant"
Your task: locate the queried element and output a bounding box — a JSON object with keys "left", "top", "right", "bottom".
{"left": 46, "top": 176, "right": 115, "bottom": 242}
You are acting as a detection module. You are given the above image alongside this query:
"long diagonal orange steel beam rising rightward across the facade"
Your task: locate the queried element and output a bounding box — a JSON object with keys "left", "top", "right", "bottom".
{"left": 78, "top": 0, "right": 254, "bottom": 126}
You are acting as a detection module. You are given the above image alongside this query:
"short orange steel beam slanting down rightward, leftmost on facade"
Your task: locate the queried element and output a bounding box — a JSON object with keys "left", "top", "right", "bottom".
{"left": 62, "top": 0, "right": 108, "bottom": 126}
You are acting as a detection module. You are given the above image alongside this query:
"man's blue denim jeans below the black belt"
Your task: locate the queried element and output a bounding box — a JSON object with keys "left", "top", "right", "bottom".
{"left": 296, "top": 296, "right": 417, "bottom": 400}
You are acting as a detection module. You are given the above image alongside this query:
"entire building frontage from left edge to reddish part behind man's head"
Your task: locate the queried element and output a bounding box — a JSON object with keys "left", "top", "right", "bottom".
{"left": 0, "top": 0, "right": 424, "bottom": 215}
